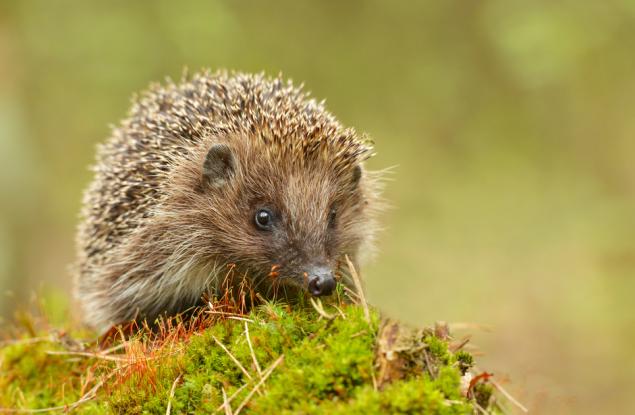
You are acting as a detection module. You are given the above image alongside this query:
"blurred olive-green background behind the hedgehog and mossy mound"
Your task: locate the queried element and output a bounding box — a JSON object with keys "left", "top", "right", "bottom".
{"left": 0, "top": 0, "right": 635, "bottom": 414}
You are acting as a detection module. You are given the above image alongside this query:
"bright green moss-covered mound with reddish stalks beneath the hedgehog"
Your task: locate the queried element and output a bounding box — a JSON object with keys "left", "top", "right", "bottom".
{"left": 0, "top": 304, "right": 500, "bottom": 414}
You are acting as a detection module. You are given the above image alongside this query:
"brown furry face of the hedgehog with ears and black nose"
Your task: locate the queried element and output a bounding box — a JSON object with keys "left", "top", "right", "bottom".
{"left": 203, "top": 144, "right": 369, "bottom": 296}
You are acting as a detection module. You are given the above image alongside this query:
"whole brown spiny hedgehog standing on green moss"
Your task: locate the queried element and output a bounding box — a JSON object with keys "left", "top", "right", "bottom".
{"left": 75, "top": 71, "right": 381, "bottom": 330}
